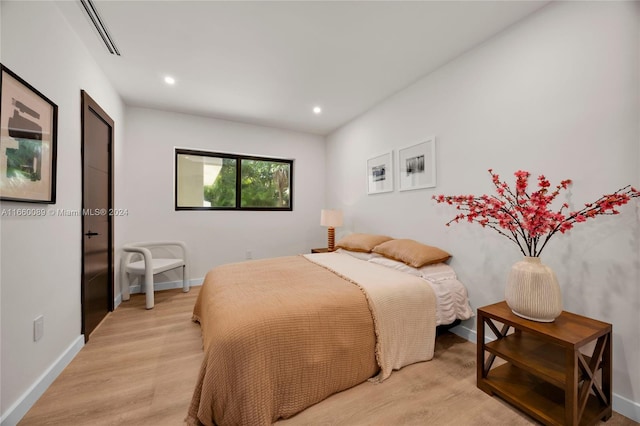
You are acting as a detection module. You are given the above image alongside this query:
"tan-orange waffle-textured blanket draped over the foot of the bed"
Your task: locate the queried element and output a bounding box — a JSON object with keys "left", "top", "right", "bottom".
{"left": 186, "top": 254, "right": 435, "bottom": 425}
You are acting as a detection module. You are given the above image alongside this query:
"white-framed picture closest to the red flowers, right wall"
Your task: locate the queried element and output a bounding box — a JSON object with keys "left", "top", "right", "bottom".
{"left": 398, "top": 137, "right": 436, "bottom": 191}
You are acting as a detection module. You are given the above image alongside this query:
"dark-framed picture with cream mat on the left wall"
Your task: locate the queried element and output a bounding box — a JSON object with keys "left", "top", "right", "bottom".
{"left": 0, "top": 64, "right": 58, "bottom": 204}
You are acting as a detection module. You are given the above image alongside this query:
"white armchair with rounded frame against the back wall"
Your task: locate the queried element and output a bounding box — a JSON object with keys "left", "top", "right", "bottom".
{"left": 120, "top": 241, "right": 189, "bottom": 309}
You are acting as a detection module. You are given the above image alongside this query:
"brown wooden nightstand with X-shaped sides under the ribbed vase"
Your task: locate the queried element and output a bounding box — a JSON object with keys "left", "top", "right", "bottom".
{"left": 477, "top": 302, "right": 612, "bottom": 425}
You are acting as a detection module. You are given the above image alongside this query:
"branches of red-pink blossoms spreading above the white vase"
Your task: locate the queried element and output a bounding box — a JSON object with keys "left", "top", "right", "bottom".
{"left": 432, "top": 169, "right": 640, "bottom": 257}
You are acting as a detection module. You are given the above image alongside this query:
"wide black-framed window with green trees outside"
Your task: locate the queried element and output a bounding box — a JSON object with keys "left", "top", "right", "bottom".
{"left": 175, "top": 149, "right": 293, "bottom": 211}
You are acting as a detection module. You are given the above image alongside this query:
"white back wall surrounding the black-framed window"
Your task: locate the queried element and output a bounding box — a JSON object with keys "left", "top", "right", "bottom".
{"left": 116, "top": 107, "right": 326, "bottom": 288}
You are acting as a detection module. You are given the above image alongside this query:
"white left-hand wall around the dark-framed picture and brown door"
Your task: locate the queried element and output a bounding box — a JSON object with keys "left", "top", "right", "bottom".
{"left": 0, "top": 1, "right": 124, "bottom": 424}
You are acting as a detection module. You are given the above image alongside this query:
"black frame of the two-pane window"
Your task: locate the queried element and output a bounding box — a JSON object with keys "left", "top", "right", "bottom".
{"left": 173, "top": 148, "right": 294, "bottom": 211}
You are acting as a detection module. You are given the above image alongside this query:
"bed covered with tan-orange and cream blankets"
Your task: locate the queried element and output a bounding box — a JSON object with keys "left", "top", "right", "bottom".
{"left": 186, "top": 237, "right": 473, "bottom": 425}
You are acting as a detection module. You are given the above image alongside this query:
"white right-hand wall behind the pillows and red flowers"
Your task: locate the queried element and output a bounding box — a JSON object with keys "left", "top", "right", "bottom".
{"left": 326, "top": 2, "right": 640, "bottom": 412}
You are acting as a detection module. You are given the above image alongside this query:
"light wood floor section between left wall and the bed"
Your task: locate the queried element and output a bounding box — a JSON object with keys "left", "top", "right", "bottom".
{"left": 19, "top": 287, "right": 203, "bottom": 426}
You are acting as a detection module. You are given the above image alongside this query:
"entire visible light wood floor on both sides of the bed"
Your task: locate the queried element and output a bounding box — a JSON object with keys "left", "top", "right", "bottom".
{"left": 19, "top": 287, "right": 638, "bottom": 426}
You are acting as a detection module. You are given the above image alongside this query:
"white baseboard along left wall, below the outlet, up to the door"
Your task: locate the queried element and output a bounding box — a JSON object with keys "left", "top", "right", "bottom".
{"left": 0, "top": 334, "right": 84, "bottom": 426}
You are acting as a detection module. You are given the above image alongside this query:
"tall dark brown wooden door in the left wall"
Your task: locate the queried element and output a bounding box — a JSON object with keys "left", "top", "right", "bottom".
{"left": 82, "top": 90, "right": 114, "bottom": 341}
